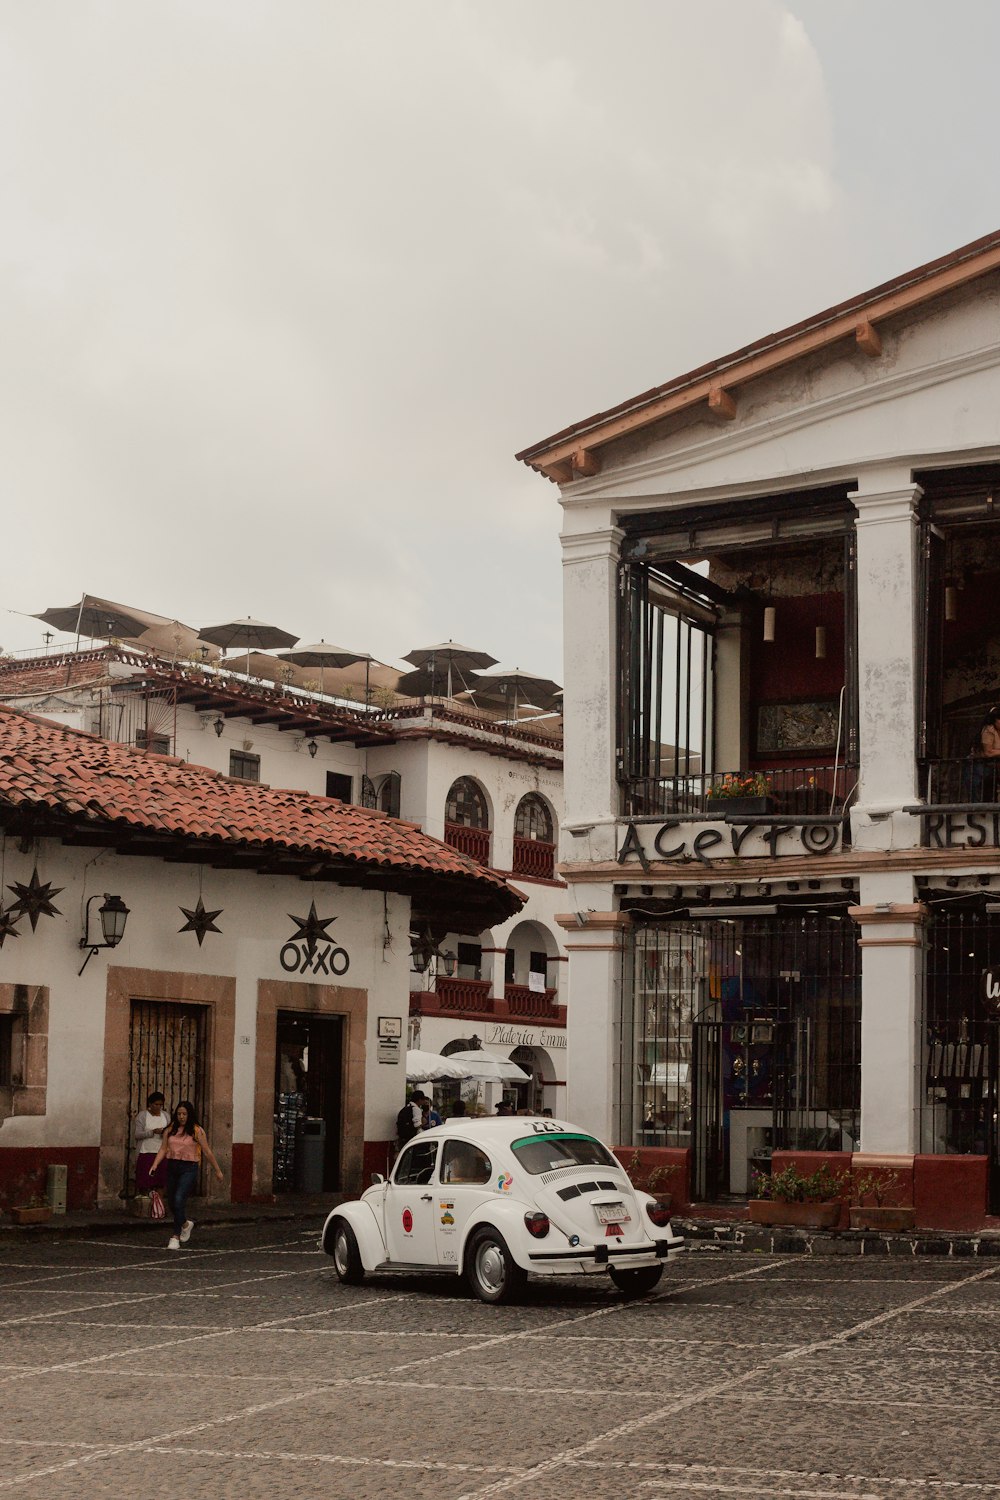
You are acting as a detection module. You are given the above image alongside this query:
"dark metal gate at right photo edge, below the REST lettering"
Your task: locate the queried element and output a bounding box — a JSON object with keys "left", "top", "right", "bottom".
{"left": 921, "top": 896, "right": 1000, "bottom": 1214}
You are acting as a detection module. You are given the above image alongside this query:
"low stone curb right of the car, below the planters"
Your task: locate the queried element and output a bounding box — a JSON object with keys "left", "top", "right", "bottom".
{"left": 673, "top": 1217, "right": 1000, "bottom": 1257}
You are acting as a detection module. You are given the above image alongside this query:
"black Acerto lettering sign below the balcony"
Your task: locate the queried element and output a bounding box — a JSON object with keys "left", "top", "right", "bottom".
{"left": 618, "top": 816, "right": 844, "bottom": 870}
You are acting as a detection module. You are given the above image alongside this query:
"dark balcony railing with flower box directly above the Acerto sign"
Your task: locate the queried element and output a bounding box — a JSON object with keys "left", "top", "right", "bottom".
{"left": 622, "top": 765, "right": 858, "bottom": 818}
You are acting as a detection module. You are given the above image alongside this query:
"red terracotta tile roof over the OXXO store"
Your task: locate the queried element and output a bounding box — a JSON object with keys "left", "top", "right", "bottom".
{"left": 0, "top": 704, "right": 523, "bottom": 930}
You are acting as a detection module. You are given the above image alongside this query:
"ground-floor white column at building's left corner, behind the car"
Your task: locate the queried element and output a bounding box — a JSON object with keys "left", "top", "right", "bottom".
{"left": 556, "top": 887, "right": 630, "bottom": 1146}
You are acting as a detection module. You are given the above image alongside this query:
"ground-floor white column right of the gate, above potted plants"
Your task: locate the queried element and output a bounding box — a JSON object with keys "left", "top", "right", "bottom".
{"left": 852, "top": 875, "right": 927, "bottom": 1155}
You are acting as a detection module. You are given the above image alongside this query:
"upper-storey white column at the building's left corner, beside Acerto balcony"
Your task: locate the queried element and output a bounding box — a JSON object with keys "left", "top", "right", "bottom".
{"left": 562, "top": 527, "right": 624, "bottom": 834}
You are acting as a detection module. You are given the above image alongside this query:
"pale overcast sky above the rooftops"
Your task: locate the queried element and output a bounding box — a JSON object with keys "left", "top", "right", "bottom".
{"left": 0, "top": 0, "right": 1000, "bottom": 681}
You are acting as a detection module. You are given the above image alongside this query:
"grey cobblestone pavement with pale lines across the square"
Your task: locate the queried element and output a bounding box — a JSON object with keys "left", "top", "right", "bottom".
{"left": 0, "top": 1224, "right": 1000, "bottom": 1500}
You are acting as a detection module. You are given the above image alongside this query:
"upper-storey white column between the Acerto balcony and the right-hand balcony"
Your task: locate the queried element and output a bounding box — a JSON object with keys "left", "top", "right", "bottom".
{"left": 850, "top": 470, "right": 922, "bottom": 822}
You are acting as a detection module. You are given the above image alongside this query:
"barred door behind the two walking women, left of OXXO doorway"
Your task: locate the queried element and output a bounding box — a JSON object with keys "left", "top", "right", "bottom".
{"left": 121, "top": 1001, "right": 208, "bottom": 1197}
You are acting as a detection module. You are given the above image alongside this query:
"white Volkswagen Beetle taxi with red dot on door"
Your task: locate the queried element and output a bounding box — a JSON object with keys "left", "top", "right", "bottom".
{"left": 322, "top": 1116, "right": 684, "bottom": 1302}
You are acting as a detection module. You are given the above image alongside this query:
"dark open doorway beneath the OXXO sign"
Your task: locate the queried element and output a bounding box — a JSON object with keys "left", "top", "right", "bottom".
{"left": 273, "top": 1010, "right": 343, "bottom": 1193}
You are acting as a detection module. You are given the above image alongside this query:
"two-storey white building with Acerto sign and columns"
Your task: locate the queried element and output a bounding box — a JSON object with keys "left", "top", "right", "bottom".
{"left": 519, "top": 225, "right": 1000, "bottom": 1227}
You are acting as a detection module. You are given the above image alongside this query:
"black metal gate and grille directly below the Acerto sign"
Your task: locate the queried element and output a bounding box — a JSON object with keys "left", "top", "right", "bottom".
{"left": 621, "top": 903, "right": 861, "bottom": 1202}
